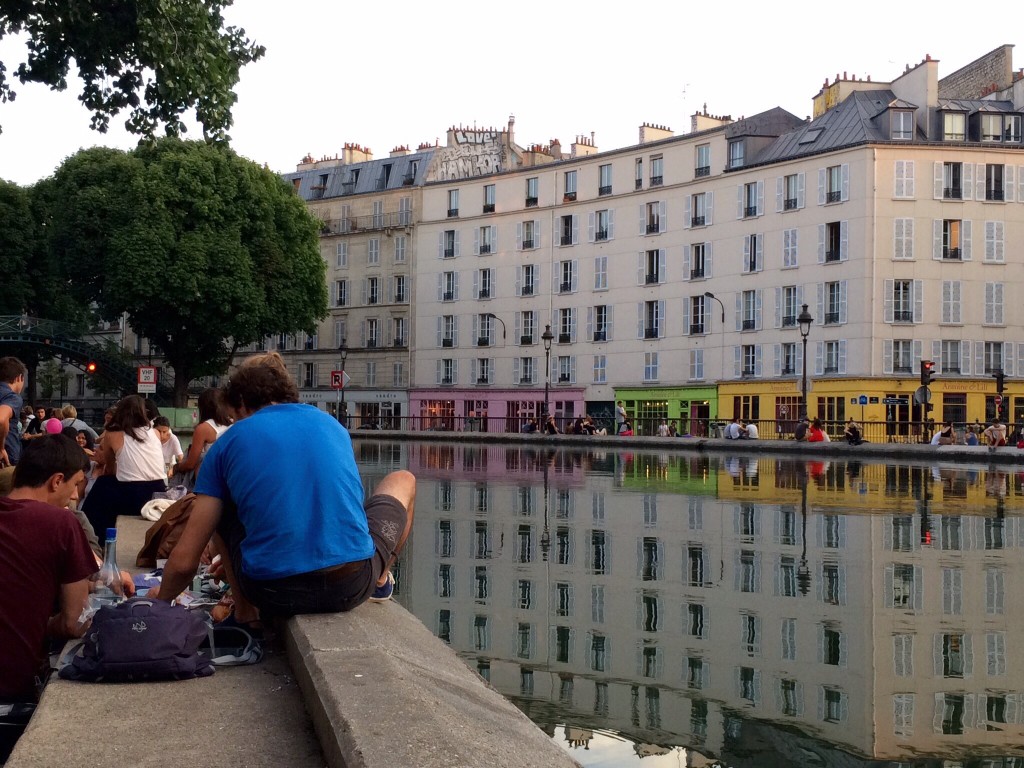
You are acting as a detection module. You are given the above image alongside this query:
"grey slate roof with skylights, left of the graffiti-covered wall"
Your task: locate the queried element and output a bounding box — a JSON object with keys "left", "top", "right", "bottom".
{"left": 282, "top": 147, "right": 434, "bottom": 201}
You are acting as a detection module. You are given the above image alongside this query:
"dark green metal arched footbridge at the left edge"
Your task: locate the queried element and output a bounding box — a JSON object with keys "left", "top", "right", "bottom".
{"left": 0, "top": 314, "right": 173, "bottom": 403}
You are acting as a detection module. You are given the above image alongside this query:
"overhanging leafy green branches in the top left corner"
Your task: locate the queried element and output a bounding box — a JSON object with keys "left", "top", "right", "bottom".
{"left": 0, "top": 0, "right": 265, "bottom": 138}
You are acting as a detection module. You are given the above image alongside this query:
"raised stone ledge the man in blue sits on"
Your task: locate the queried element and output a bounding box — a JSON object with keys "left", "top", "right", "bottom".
{"left": 285, "top": 602, "right": 579, "bottom": 768}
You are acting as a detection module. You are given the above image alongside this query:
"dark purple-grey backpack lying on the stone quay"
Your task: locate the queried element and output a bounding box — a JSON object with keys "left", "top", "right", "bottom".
{"left": 58, "top": 597, "right": 213, "bottom": 683}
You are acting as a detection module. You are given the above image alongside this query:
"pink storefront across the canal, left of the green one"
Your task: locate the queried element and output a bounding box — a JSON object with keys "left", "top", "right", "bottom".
{"left": 409, "top": 386, "right": 587, "bottom": 432}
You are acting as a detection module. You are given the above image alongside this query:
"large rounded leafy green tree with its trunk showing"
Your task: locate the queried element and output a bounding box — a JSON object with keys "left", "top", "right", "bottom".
{"left": 48, "top": 138, "right": 327, "bottom": 406}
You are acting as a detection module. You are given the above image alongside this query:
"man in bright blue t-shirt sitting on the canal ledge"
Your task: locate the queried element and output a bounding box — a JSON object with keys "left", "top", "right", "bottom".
{"left": 151, "top": 352, "right": 416, "bottom": 624}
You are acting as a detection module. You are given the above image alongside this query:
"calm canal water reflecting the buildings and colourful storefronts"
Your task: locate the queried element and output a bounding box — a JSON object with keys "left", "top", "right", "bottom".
{"left": 354, "top": 439, "right": 1024, "bottom": 768}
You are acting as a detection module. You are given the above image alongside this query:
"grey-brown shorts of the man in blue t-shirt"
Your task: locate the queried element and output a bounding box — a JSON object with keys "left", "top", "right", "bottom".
{"left": 219, "top": 494, "right": 409, "bottom": 617}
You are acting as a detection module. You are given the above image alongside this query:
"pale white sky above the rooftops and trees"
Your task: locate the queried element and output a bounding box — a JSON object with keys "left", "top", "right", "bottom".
{"left": 0, "top": 0, "right": 1024, "bottom": 184}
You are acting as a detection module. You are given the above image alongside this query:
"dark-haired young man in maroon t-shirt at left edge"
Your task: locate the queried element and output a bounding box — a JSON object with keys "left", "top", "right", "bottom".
{"left": 0, "top": 434, "right": 96, "bottom": 701}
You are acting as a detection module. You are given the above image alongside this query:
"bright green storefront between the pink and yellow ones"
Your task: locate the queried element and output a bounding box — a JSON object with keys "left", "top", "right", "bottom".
{"left": 615, "top": 386, "right": 718, "bottom": 437}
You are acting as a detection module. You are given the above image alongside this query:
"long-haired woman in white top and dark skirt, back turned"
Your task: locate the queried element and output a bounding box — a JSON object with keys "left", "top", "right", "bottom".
{"left": 82, "top": 394, "right": 167, "bottom": 543}
